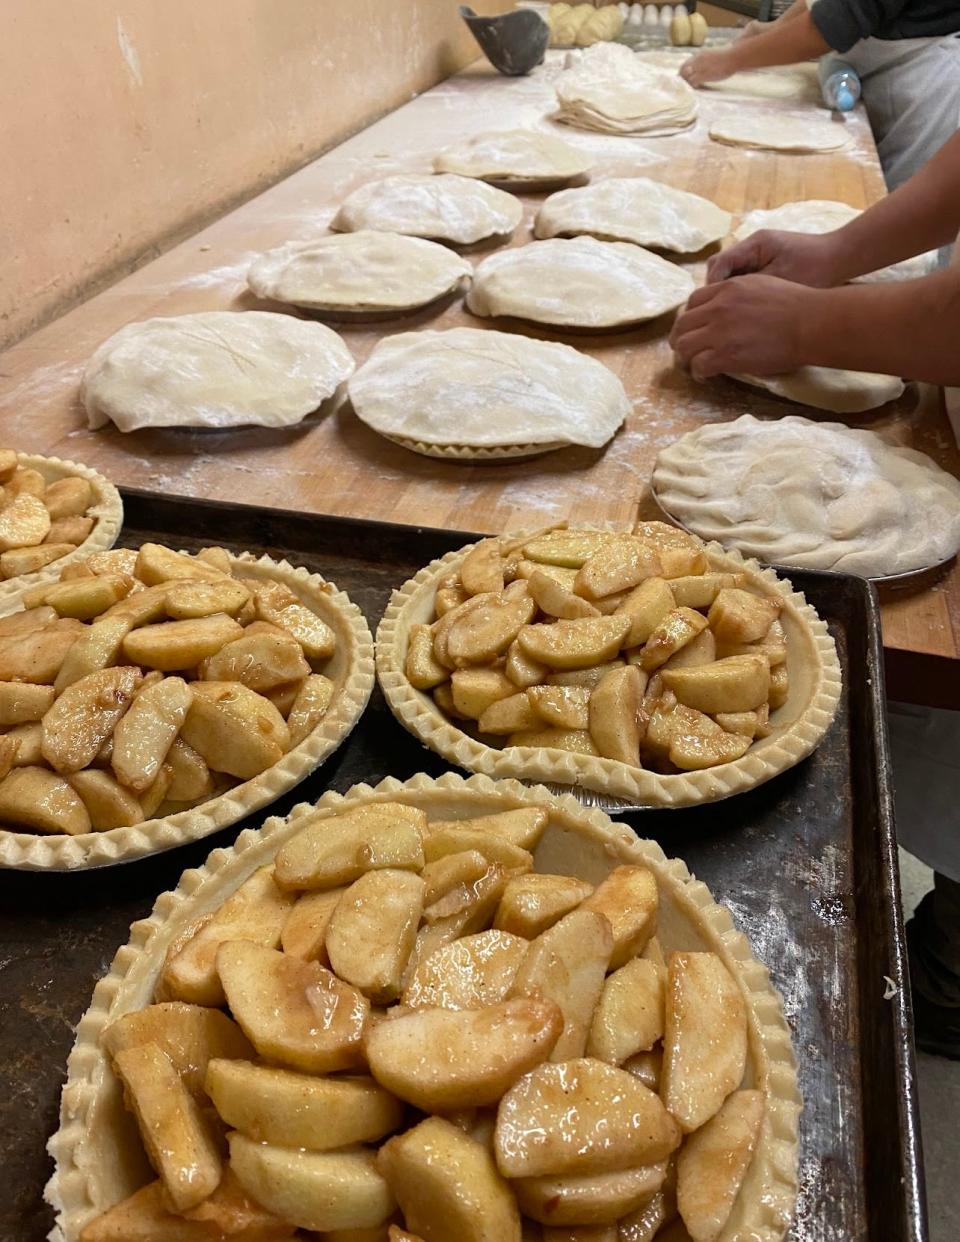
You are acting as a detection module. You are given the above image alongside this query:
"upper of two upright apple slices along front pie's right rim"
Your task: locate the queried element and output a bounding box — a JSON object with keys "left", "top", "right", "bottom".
{"left": 661, "top": 953, "right": 746, "bottom": 1134}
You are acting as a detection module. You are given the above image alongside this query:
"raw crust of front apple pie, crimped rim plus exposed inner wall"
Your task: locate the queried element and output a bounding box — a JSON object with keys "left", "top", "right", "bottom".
{"left": 45, "top": 773, "right": 802, "bottom": 1242}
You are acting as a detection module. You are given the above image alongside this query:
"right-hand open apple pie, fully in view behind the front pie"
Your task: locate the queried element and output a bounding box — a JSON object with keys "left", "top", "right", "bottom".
{"left": 376, "top": 522, "right": 841, "bottom": 806}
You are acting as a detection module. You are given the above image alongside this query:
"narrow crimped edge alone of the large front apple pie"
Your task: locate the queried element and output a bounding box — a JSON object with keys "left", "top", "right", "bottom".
{"left": 43, "top": 773, "right": 802, "bottom": 1242}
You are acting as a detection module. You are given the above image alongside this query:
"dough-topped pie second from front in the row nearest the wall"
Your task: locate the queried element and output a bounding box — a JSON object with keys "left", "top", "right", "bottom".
{"left": 247, "top": 229, "right": 473, "bottom": 312}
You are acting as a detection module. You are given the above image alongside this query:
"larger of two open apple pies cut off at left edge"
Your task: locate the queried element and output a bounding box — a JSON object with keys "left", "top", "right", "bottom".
{"left": 0, "top": 543, "right": 373, "bottom": 868}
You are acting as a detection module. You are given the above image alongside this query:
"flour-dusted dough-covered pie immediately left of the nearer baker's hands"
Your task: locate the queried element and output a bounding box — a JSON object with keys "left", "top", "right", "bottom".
{"left": 467, "top": 237, "right": 695, "bottom": 330}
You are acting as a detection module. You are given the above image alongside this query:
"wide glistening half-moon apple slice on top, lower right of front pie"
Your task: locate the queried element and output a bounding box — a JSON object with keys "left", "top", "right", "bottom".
{"left": 494, "top": 1057, "right": 681, "bottom": 1177}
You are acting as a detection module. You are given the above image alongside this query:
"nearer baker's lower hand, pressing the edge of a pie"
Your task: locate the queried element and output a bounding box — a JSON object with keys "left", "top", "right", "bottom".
{"left": 669, "top": 276, "right": 822, "bottom": 380}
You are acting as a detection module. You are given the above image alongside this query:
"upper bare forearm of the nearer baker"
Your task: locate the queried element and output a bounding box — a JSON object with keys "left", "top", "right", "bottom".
{"left": 832, "top": 134, "right": 960, "bottom": 283}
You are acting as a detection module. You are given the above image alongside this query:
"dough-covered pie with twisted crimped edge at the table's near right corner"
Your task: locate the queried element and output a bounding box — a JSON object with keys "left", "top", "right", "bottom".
{"left": 652, "top": 414, "right": 960, "bottom": 578}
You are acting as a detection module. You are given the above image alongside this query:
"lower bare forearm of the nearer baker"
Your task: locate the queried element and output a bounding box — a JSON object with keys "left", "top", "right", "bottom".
{"left": 802, "top": 268, "right": 960, "bottom": 388}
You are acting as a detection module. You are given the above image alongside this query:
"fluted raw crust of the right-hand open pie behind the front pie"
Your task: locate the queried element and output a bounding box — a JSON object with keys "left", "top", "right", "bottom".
{"left": 376, "top": 531, "right": 842, "bottom": 806}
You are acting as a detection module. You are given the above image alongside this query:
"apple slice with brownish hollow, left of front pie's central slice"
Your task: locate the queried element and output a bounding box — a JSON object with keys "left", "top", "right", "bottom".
{"left": 216, "top": 940, "right": 370, "bottom": 1074}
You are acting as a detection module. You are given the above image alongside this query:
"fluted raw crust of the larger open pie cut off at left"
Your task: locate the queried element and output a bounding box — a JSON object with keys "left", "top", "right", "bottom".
{"left": 0, "top": 553, "right": 374, "bottom": 871}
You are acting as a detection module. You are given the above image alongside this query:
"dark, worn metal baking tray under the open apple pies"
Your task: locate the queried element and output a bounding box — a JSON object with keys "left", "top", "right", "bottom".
{"left": 0, "top": 491, "right": 928, "bottom": 1242}
